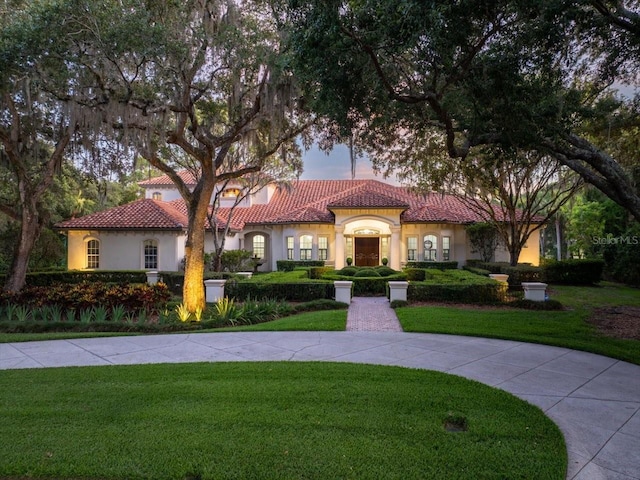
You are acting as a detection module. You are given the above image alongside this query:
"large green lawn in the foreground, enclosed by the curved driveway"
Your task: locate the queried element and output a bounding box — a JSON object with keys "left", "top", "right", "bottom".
{"left": 0, "top": 362, "right": 567, "bottom": 480}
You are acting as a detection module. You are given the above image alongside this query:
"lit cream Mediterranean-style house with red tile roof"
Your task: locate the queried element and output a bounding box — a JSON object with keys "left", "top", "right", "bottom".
{"left": 57, "top": 171, "right": 539, "bottom": 271}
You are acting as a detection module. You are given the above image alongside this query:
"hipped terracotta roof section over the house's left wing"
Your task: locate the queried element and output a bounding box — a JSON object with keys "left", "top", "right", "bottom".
{"left": 56, "top": 198, "right": 187, "bottom": 230}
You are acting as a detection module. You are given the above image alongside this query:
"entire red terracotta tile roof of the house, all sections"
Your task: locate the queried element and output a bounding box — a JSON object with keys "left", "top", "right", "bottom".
{"left": 57, "top": 177, "right": 508, "bottom": 231}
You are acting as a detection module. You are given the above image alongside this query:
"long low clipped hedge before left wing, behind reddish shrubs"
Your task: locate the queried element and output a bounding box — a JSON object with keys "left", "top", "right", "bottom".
{"left": 0, "top": 270, "right": 147, "bottom": 287}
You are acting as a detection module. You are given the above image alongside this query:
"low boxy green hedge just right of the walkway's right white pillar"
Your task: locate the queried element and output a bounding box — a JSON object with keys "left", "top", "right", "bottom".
{"left": 407, "top": 282, "right": 508, "bottom": 303}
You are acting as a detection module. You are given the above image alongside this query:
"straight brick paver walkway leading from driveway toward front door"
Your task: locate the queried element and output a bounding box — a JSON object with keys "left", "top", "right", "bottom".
{"left": 347, "top": 297, "right": 402, "bottom": 332}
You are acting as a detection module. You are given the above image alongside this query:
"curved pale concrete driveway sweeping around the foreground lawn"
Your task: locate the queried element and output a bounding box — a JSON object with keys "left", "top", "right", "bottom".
{"left": 0, "top": 332, "right": 640, "bottom": 480}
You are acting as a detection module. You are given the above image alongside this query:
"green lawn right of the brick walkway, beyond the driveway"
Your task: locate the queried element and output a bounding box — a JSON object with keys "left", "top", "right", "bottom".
{"left": 396, "top": 284, "right": 640, "bottom": 365}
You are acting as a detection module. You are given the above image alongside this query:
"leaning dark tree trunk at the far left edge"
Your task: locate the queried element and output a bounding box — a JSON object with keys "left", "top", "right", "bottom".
{"left": 4, "top": 203, "right": 42, "bottom": 292}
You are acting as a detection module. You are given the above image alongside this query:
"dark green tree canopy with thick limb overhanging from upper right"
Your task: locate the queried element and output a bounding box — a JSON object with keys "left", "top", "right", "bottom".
{"left": 281, "top": 0, "right": 640, "bottom": 219}
